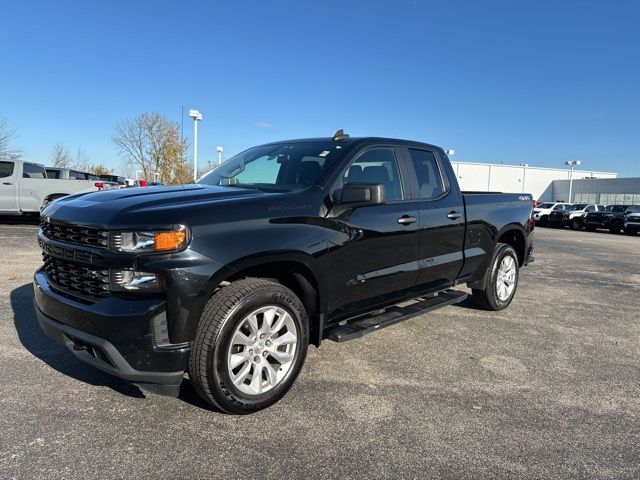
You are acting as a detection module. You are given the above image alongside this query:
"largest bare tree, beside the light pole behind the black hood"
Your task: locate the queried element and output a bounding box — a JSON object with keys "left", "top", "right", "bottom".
{"left": 113, "top": 113, "right": 188, "bottom": 183}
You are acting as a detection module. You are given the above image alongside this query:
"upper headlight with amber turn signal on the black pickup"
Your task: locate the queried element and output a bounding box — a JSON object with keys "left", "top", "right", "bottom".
{"left": 109, "top": 227, "right": 189, "bottom": 253}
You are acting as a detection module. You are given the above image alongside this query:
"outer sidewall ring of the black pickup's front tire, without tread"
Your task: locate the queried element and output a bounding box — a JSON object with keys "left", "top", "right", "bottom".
{"left": 206, "top": 286, "right": 309, "bottom": 413}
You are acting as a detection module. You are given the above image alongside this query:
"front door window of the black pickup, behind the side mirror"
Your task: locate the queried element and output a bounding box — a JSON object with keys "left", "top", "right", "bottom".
{"left": 341, "top": 147, "right": 402, "bottom": 200}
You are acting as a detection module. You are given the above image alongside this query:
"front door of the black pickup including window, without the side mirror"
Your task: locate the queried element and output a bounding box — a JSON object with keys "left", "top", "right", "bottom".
{"left": 324, "top": 146, "right": 419, "bottom": 318}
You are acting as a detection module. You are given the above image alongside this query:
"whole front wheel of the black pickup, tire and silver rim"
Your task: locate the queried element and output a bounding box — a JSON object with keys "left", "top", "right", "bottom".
{"left": 189, "top": 278, "right": 309, "bottom": 414}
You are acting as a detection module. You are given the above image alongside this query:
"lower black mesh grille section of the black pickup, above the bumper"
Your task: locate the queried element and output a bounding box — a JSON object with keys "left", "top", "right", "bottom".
{"left": 43, "top": 254, "right": 109, "bottom": 297}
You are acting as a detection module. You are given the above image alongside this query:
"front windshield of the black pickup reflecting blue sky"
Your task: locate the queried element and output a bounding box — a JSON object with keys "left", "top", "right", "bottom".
{"left": 196, "top": 142, "right": 343, "bottom": 192}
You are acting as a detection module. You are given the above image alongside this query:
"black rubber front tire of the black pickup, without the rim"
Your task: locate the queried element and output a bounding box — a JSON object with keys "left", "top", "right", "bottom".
{"left": 189, "top": 278, "right": 309, "bottom": 414}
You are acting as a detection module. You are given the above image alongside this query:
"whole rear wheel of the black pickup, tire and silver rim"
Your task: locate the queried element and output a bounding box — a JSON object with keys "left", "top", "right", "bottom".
{"left": 472, "top": 243, "right": 520, "bottom": 311}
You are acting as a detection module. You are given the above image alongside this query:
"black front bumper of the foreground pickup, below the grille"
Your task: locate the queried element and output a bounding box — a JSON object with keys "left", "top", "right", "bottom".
{"left": 34, "top": 270, "right": 190, "bottom": 395}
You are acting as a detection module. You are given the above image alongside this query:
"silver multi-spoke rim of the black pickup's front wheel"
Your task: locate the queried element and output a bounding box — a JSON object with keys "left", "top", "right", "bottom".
{"left": 227, "top": 305, "right": 298, "bottom": 395}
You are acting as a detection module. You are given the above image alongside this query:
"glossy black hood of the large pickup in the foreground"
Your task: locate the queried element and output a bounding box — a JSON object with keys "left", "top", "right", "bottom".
{"left": 42, "top": 184, "right": 273, "bottom": 228}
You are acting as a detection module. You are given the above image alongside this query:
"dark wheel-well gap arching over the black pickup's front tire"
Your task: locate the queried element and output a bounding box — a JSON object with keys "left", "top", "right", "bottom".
{"left": 225, "top": 261, "right": 320, "bottom": 343}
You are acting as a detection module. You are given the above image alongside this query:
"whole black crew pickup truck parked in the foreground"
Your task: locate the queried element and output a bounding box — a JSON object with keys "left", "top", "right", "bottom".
{"left": 34, "top": 132, "right": 534, "bottom": 413}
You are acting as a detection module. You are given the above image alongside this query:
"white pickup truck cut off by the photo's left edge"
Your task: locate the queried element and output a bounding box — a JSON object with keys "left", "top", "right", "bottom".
{"left": 0, "top": 160, "right": 111, "bottom": 215}
